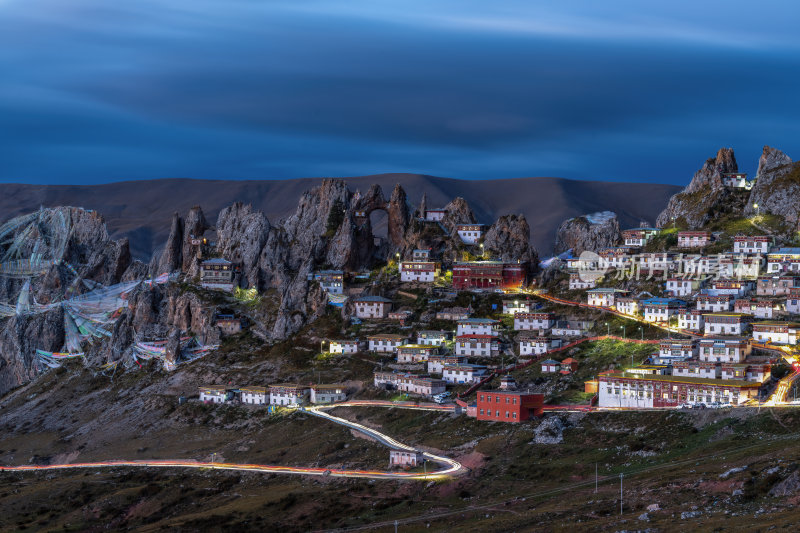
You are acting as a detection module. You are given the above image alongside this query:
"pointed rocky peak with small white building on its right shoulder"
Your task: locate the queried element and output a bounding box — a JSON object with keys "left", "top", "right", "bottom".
{"left": 656, "top": 148, "right": 747, "bottom": 229}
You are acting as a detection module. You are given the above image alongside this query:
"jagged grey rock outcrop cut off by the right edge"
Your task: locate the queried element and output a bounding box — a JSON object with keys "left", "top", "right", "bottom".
{"left": 745, "top": 146, "right": 800, "bottom": 223}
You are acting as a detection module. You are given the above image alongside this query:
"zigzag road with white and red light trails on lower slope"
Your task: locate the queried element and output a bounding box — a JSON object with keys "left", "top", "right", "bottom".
{"left": 0, "top": 400, "right": 468, "bottom": 481}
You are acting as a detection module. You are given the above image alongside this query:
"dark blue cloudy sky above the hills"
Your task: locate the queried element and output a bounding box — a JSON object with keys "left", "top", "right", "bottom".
{"left": 0, "top": 0, "right": 800, "bottom": 184}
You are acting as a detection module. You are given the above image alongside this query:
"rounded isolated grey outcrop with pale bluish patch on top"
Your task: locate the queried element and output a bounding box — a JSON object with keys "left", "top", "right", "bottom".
{"left": 554, "top": 211, "right": 622, "bottom": 256}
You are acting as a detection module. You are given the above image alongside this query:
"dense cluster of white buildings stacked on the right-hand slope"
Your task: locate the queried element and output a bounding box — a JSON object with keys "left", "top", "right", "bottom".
{"left": 556, "top": 220, "right": 800, "bottom": 408}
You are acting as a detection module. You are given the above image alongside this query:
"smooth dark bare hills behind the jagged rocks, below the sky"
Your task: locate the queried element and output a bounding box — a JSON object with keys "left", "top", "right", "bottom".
{"left": 0, "top": 174, "right": 680, "bottom": 258}
